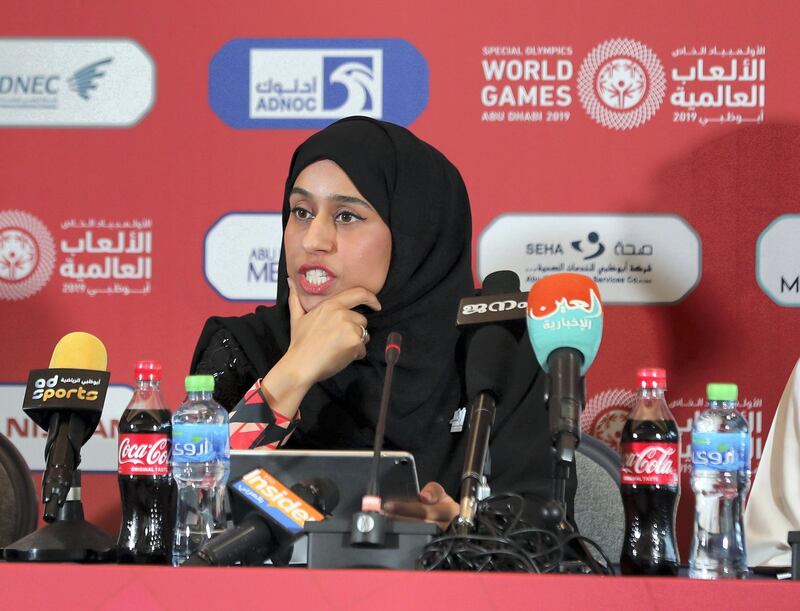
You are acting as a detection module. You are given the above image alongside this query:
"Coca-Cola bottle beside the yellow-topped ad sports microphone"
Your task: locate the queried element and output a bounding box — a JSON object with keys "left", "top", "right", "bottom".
{"left": 117, "top": 361, "right": 175, "bottom": 564}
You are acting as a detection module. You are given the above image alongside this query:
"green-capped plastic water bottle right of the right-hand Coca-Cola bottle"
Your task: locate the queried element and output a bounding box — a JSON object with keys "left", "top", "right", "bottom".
{"left": 689, "top": 384, "right": 750, "bottom": 579}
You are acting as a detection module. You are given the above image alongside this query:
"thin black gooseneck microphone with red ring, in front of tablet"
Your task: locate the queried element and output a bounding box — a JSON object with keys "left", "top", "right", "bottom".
{"left": 350, "top": 331, "right": 403, "bottom": 545}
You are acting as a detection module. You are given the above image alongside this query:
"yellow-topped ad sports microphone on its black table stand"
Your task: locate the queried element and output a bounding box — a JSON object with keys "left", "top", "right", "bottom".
{"left": 4, "top": 332, "right": 116, "bottom": 562}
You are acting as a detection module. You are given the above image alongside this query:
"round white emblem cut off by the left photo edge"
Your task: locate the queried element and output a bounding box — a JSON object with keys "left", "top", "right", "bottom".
{"left": 0, "top": 210, "right": 56, "bottom": 300}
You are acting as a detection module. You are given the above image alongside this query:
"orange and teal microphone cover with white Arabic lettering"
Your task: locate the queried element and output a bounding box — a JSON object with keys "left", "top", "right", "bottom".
{"left": 528, "top": 273, "right": 603, "bottom": 376}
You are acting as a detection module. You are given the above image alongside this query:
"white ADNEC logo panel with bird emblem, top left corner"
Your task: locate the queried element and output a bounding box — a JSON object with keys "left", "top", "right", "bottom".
{"left": 0, "top": 38, "right": 155, "bottom": 127}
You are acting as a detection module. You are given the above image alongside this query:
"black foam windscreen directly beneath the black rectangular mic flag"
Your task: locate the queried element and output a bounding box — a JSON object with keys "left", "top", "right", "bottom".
{"left": 466, "top": 325, "right": 517, "bottom": 401}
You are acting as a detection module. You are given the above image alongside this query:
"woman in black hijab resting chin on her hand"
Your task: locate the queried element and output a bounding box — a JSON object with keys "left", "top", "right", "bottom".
{"left": 192, "top": 117, "right": 568, "bottom": 523}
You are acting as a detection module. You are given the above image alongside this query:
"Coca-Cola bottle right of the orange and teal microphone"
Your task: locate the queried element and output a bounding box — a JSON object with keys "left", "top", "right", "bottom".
{"left": 620, "top": 369, "right": 681, "bottom": 575}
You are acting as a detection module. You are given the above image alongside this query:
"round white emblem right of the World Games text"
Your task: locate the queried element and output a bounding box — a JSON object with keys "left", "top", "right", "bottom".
{"left": 578, "top": 38, "right": 667, "bottom": 130}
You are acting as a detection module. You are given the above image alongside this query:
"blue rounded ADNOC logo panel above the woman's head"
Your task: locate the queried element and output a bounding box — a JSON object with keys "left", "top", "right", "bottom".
{"left": 209, "top": 39, "right": 428, "bottom": 129}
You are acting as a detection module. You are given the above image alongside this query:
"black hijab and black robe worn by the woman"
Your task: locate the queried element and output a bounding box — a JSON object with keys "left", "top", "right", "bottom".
{"left": 193, "top": 117, "right": 474, "bottom": 483}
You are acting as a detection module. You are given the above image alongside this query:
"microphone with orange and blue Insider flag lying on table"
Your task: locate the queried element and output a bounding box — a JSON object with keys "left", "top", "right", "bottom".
{"left": 181, "top": 468, "right": 339, "bottom": 566}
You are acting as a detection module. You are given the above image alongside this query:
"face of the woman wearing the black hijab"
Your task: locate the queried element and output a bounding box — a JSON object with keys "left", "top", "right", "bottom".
{"left": 283, "top": 160, "right": 392, "bottom": 312}
